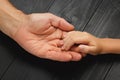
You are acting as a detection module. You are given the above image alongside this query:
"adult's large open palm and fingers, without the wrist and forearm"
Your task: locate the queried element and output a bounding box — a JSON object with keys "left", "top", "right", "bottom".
{"left": 13, "top": 13, "right": 81, "bottom": 61}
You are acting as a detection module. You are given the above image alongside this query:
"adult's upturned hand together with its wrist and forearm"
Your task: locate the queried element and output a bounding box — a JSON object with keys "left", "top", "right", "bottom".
{"left": 0, "top": 0, "right": 81, "bottom": 61}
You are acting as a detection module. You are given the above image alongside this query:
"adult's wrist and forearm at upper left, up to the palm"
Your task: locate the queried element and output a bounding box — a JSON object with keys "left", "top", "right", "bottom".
{"left": 0, "top": 0, "right": 27, "bottom": 37}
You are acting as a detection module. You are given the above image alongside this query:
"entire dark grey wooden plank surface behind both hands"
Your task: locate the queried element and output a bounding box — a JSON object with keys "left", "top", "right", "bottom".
{"left": 0, "top": 0, "right": 120, "bottom": 80}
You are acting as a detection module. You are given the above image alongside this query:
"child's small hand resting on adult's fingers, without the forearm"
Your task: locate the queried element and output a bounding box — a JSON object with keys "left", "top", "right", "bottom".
{"left": 62, "top": 31, "right": 101, "bottom": 55}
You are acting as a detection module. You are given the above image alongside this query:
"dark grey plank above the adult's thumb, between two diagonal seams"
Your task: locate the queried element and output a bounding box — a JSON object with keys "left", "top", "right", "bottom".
{"left": 49, "top": 0, "right": 102, "bottom": 30}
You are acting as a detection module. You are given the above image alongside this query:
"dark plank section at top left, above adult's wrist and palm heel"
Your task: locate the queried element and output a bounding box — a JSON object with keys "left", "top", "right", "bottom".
{"left": 10, "top": 0, "right": 54, "bottom": 14}
